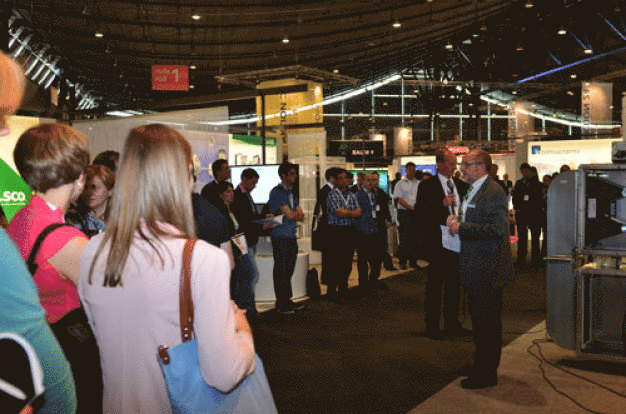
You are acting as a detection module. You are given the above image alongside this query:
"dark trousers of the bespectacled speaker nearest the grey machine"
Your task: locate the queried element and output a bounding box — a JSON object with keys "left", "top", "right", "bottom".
{"left": 465, "top": 287, "right": 502, "bottom": 376}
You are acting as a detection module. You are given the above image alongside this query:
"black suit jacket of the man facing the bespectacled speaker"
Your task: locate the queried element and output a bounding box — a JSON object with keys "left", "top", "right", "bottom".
{"left": 415, "top": 175, "right": 469, "bottom": 260}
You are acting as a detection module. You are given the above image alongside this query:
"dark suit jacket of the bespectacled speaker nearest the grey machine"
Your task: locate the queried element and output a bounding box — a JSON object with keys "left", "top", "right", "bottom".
{"left": 459, "top": 177, "right": 513, "bottom": 289}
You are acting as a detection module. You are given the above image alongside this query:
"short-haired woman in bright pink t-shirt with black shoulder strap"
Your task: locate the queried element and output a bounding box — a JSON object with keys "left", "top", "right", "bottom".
{"left": 7, "top": 124, "right": 102, "bottom": 413}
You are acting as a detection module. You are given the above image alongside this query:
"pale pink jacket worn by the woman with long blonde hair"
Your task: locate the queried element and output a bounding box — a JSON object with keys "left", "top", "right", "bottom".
{"left": 79, "top": 226, "right": 254, "bottom": 414}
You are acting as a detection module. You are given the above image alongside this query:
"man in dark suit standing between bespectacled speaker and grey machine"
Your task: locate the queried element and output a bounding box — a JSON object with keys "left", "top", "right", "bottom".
{"left": 513, "top": 163, "right": 543, "bottom": 266}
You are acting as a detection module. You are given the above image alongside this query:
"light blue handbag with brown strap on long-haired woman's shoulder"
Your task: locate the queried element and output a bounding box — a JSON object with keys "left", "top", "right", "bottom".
{"left": 157, "top": 239, "right": 277, "bottom": 414}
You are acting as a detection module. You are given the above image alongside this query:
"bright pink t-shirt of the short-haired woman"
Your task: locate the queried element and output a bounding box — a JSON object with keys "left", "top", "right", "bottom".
{"left": 7, "top": 195, "right": 87, "bottom": 323}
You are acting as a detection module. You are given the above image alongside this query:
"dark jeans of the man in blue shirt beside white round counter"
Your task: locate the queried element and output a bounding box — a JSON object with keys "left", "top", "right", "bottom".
{"left": 272, "top": 236, "right": 298, "bottom": 309}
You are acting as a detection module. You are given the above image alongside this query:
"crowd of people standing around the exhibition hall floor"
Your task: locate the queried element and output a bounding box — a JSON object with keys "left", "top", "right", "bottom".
{"left": 0, "top": 47, "right": 564, "bottom": 413}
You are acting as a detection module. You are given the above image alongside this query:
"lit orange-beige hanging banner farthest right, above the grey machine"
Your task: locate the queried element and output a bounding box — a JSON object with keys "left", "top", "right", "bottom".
{"left": 580, "top": 82, "right": 613, "bottom": 131}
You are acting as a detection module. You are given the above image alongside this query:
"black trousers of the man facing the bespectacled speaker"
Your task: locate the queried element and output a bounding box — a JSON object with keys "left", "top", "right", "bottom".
{"left": 424, "top": 248, "right": 461, "bottom": 330}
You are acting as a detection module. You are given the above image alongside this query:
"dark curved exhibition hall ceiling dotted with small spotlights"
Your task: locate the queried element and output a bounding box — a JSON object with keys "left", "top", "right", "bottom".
{"left": 4, "top": 0, "right": 626, "bottom": 116}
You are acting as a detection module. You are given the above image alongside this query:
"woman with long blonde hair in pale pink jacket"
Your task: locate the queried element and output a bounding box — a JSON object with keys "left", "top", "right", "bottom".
{"left": 79, "top": 124, "right": 255, "bottom": 413}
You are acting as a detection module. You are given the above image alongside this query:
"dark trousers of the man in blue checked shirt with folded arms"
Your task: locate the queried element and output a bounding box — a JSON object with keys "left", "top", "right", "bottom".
{"left": 326, "top": 225, "right": 355, "bottom": 298}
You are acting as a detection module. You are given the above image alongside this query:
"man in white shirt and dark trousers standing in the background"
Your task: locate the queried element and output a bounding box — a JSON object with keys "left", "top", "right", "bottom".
{"left": 393, "top": 162, "right": 419, "bottom": 269}
